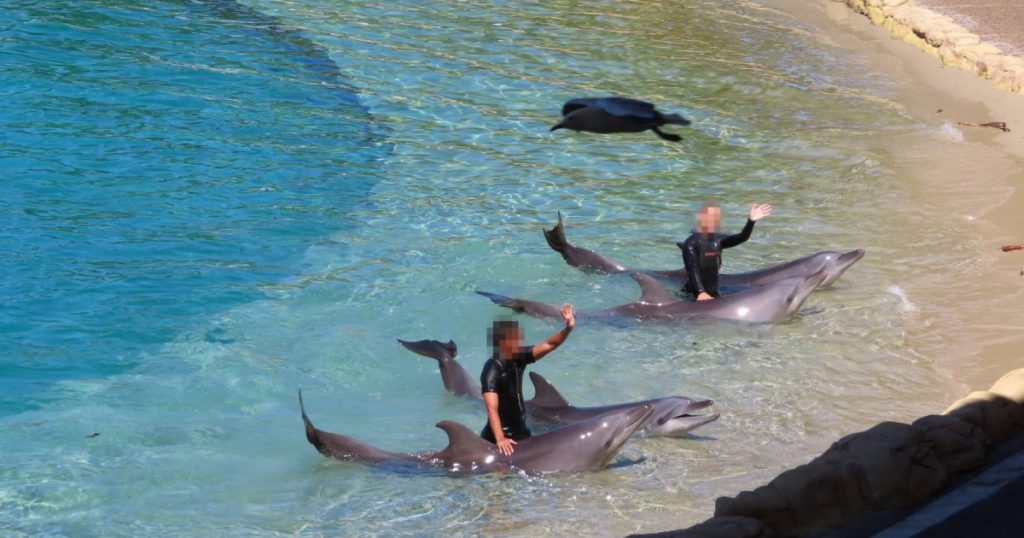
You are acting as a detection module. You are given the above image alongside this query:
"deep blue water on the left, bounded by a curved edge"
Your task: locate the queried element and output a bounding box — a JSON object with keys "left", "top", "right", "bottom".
{"left": 0, "top": 1, "right": 390, "bottom": 415}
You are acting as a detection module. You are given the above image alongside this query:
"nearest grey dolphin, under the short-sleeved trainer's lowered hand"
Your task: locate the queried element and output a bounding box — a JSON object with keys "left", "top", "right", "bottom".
{"left": 299, "top": 390, "right": 654, "bottom": 473}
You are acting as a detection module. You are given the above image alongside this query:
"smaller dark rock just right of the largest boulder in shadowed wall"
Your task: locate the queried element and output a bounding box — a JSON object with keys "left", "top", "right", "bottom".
{"left": 910, "top": 415, "right": 985, "bottom": 474}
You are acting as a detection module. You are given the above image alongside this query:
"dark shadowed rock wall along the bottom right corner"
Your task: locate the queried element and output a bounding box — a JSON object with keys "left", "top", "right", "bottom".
{"left": 638, "top": 368, "right": 1024, "bottom": 538}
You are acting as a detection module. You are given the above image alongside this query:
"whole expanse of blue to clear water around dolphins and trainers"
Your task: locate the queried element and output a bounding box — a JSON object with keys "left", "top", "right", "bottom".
{"left": 0, "top": 0, "right": 991, "bottom": 536}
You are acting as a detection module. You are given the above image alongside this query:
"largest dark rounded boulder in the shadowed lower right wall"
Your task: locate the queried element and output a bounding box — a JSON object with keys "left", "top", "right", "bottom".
{"left": 818, "top": 422, "right": 947, "bottom": 508}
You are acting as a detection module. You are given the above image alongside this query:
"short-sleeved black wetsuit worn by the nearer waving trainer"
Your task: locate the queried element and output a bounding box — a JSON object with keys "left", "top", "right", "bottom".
{"left": 480, "top": 346, "right": 537, "bottom": 443}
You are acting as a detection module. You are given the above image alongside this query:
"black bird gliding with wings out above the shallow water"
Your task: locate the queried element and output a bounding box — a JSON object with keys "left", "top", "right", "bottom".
{"left": 551, "top": 97, "right": 690, "bottom": 142}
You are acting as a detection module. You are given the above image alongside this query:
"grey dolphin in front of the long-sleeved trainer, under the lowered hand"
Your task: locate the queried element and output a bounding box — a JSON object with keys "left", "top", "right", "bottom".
{"left": 476, "top": 270, "right": 828, "bottom": 323}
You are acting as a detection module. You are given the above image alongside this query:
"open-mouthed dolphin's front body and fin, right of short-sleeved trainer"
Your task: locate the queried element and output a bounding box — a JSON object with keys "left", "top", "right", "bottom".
{"left": 526, "top": 372, "right": 720, "bottom": 438}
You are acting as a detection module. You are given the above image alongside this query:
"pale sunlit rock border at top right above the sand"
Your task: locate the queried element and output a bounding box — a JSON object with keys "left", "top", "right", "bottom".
{"left": 837, "top": 0, "right": 1024, "bottom": 94}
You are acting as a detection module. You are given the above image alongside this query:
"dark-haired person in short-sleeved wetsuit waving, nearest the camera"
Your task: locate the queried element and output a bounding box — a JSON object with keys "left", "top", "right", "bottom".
{"left": 480, "top": 303, "right": 575, "bottom": 455}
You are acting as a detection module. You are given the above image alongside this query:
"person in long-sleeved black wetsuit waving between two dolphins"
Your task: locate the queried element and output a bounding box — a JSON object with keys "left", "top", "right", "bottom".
{"left": 676, "top": 204, "right": 771, "bottom": 300}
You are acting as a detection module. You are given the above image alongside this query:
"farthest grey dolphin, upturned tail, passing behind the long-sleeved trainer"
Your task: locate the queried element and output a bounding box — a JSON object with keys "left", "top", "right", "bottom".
{"left": 544, "top": 211, "right": 864, "bottom": 288}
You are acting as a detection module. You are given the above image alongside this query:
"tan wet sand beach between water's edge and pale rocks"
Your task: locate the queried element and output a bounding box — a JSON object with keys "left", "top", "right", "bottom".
{"left": 794, "top": 1, "right": 1024, "bottom": 398}
